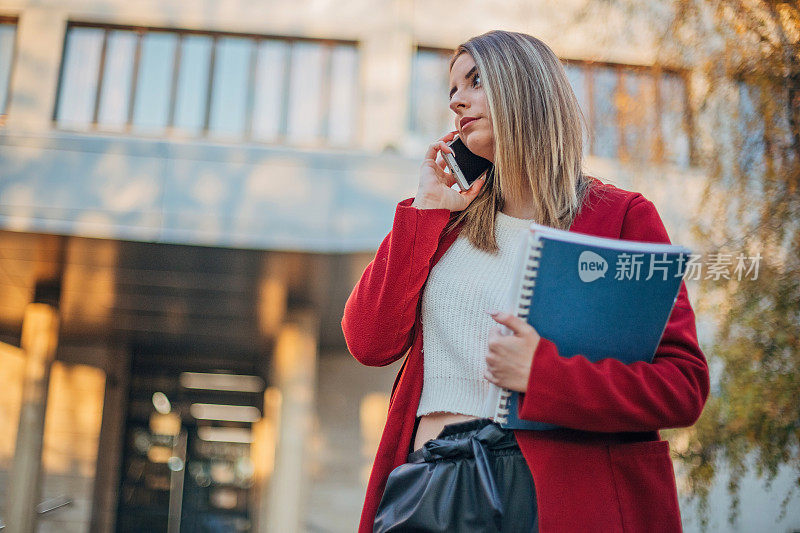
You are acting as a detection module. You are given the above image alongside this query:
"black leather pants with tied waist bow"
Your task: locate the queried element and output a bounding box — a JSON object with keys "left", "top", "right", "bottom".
{"left": 373, "top": 418, "right": 538, "bottom": 533}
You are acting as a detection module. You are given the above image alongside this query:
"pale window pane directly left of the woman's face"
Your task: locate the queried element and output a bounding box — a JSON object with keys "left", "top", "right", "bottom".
{"left": 411, "top": 50, "right": 455, "bottom": 140}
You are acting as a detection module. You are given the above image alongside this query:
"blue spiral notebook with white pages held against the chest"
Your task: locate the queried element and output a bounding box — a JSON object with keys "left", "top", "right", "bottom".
{"left": 487, "top": 224, "right": 691, "bottom": 430}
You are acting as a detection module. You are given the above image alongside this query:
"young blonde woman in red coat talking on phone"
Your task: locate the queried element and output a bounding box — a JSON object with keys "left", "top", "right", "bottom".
{"left": 342, "top": 31, "right": 709, "bottom": 533}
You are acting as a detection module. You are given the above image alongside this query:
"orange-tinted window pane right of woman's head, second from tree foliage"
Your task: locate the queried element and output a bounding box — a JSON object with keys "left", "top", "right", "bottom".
{"left": 617, "top": 70, "right": 660, "bottom": 161}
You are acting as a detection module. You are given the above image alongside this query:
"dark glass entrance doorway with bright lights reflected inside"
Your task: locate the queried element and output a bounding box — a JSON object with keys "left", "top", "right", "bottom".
{"left": 115, "top": 345, "right": 268, "bottom": 533}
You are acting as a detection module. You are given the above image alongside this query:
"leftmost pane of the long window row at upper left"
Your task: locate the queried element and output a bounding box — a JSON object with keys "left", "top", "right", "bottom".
{"left": 56, "top": 28, "right": 103, "bottom": 129}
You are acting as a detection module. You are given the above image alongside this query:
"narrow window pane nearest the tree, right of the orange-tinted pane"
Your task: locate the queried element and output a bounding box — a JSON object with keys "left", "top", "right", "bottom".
{"left": 659, "top": 74, "right": 689, "bottom": 167}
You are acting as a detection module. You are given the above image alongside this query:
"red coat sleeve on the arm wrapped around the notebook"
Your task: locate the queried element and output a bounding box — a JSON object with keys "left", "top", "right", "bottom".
{"left": 520, "top": 197, "right": 709, "bottom": 432}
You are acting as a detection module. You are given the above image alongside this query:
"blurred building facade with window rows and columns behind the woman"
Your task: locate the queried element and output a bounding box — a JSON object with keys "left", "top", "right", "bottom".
{"left": 0, "top": 0, "right": 791, "bottom": 532}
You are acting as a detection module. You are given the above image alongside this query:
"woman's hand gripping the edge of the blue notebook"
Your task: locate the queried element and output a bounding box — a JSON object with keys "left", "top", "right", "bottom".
{"left": 483, "top": 311, "right": 541, "bottom": 392}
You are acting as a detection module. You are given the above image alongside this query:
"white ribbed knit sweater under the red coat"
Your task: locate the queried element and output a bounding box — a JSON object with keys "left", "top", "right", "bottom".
{"left": 417, "top": 212, "right": 533, "bottom": 417}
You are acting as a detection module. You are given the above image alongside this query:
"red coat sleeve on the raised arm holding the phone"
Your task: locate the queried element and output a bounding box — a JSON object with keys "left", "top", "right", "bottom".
{"left": 342, "top": 198, "right": 450, "bottom": 366}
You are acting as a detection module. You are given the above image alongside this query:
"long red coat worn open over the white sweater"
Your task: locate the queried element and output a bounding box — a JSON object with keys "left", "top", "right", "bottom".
{"left": 342, "top": 178, "right": 709, "bottom": 533}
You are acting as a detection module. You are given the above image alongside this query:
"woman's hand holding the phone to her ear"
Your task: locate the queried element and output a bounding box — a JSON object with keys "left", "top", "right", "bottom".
{"left": 411, "top": 131, "right": 486, "bottom": 211}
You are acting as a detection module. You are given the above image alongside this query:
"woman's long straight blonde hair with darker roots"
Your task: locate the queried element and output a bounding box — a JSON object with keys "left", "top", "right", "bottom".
{"left": 447, "top": 31, "right": 591, "bottom": 252}
